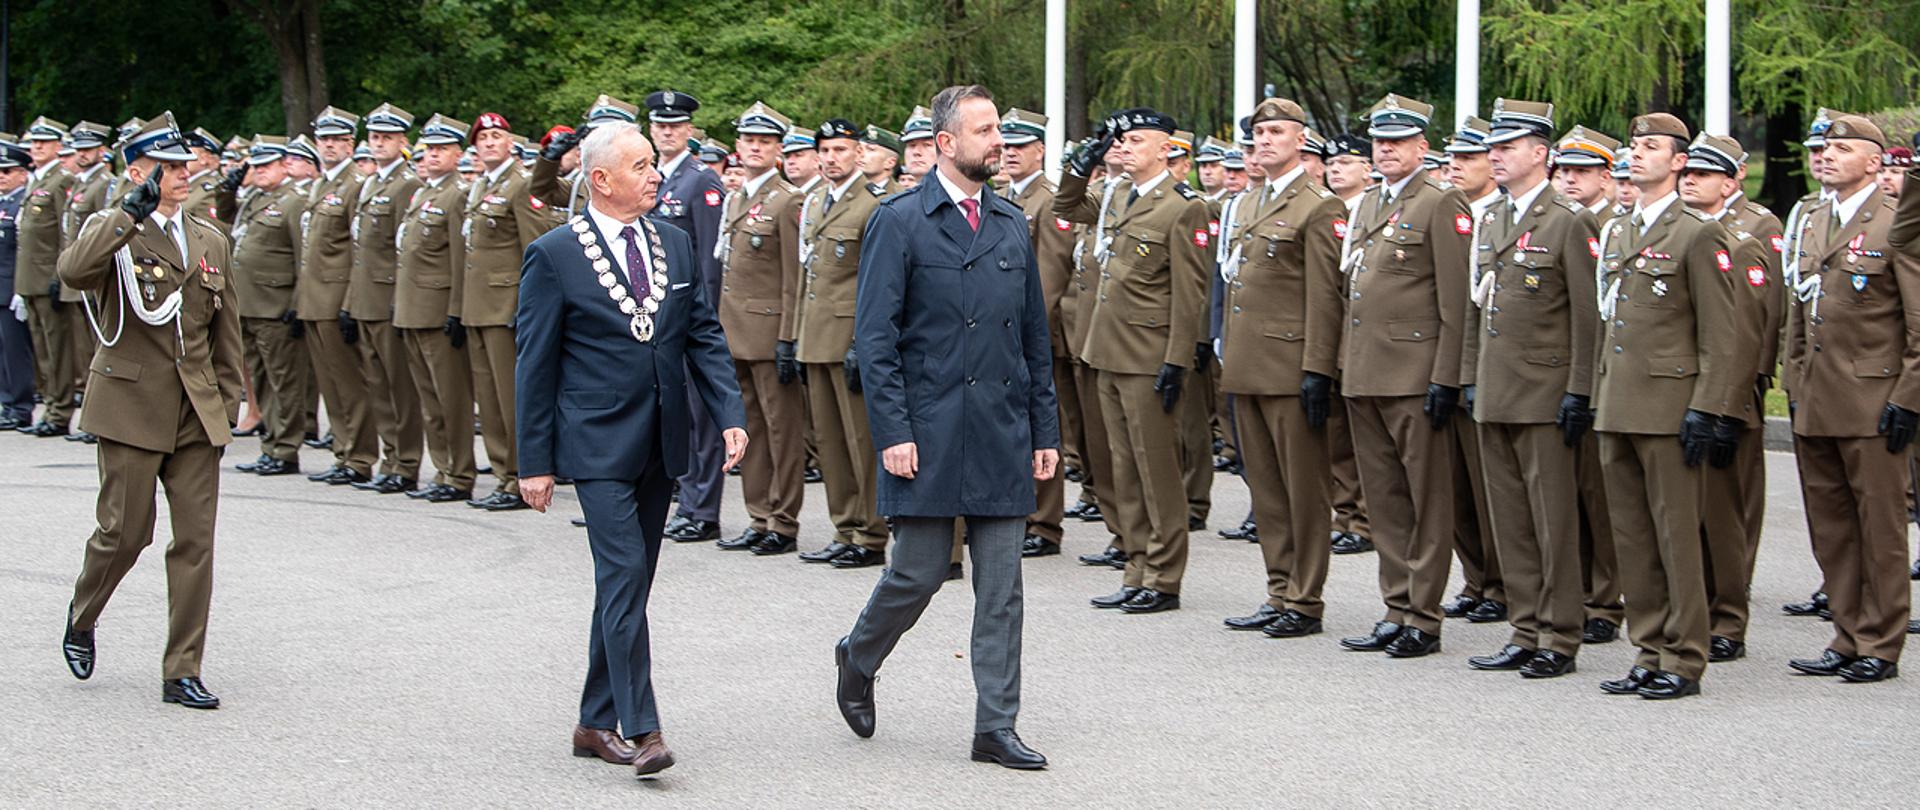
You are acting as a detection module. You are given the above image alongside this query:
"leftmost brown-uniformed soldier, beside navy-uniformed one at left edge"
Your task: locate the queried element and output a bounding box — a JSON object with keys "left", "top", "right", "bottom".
{"left": 13, "top": 115, "right": 86, "bottom": 438}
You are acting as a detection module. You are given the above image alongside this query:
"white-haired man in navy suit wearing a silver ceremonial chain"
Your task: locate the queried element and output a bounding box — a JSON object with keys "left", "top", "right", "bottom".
{"left": 515, "top": 123, "right": 747, "bottom": 777}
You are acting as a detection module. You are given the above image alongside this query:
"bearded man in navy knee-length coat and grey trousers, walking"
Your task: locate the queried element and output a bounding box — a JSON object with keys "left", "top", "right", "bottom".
{"left": 833, "top": 84, "right": 1060, "bottom": 770}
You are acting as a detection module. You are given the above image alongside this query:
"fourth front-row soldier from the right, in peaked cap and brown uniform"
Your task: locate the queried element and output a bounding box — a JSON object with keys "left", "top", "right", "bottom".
{"left": 1340, "top": 94, "right": 1473, "bottom": 658}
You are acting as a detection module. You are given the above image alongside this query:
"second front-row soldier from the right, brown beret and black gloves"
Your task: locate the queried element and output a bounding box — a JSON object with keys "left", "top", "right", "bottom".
{"left": 1594, "top": 113, "right": 1753, "bottom": 699}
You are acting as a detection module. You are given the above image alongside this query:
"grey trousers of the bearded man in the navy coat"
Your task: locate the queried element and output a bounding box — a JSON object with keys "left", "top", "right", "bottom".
{"left": 847, "top": 514, "right": 1027, "bottom": 733}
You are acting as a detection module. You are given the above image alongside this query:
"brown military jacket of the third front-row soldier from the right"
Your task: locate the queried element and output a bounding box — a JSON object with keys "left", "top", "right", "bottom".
{"left": 1461, "top": 182, "right": 1599, "bottom": 424}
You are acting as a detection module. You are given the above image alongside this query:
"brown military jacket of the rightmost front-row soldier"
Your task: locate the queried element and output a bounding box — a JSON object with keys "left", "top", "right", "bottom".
{"left": 1788, "top": 188, "right": 1920, "bottom": 438}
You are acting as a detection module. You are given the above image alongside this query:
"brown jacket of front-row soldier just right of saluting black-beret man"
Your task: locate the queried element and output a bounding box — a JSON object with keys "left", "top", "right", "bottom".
{"left": 1219, "top": 173, "right": 1346, "bottom": 397}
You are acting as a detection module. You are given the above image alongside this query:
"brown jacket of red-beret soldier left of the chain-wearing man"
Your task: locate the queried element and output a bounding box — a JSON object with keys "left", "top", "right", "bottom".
{"left": 459, "top": 159, "right": 561, "bottom": 326}
